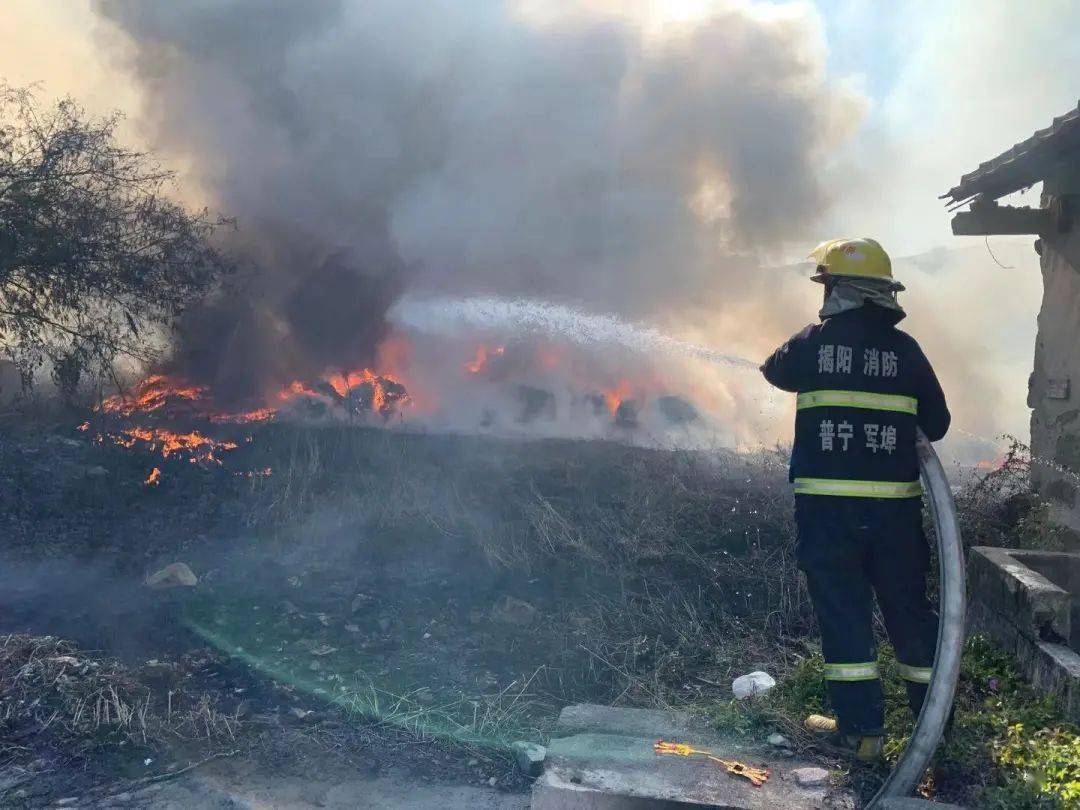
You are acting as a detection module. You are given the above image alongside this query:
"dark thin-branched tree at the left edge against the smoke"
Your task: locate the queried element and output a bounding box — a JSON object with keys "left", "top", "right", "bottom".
{"left": 0, "top": 84, "right": 231, "bottom": 393}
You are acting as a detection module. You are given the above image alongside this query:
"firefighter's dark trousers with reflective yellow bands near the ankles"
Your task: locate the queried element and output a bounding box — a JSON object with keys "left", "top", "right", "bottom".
{"left": 795, "top": 495, "right": 937, "bottom": 734}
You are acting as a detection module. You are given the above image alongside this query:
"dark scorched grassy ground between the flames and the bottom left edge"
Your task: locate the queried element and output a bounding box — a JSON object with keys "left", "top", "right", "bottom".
{"left": 0, "top": 420, "right": 820, "bottom": 807}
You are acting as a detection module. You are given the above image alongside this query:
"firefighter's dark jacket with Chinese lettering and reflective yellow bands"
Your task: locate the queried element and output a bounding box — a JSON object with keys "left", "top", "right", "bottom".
{"left": 761, "top": 303, "right": 950, "bottom": 498}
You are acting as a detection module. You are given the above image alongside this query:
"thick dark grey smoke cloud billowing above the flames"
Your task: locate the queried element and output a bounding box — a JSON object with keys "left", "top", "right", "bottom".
{"left": 96, "top": 0, "right": 860, "bottom": 403}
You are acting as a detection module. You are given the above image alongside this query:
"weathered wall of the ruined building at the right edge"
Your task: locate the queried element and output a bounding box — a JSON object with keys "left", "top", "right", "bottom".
{"left": 1028, "top": 171, "right": 1080, "bottom": 545}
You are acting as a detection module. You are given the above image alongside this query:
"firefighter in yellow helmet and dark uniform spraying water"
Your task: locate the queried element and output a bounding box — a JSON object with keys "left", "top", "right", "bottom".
{"left": 761, "top": 239, "right": 949, "bottom": 760}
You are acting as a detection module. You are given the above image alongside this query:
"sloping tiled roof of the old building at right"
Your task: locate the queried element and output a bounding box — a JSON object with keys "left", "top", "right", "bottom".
{"left": 942, "top": 104, "right": 1080, "bottom": 205}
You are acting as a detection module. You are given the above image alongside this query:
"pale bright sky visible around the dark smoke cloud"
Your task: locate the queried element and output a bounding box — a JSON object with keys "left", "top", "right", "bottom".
{"left": 0, "top": 0, "right": 1080, "bottom": 457}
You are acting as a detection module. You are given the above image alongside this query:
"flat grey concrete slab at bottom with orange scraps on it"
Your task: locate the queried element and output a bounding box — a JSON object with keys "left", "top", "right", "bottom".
{"left": 532, "top": 705, "right": 845, "bottom": 810}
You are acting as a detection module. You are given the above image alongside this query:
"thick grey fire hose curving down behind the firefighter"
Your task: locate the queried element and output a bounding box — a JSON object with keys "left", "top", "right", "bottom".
{"left": 866, "top": 430, "right": 966, "bottom": 810}
